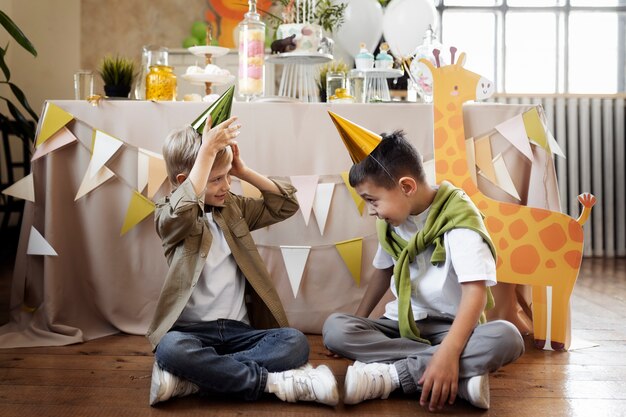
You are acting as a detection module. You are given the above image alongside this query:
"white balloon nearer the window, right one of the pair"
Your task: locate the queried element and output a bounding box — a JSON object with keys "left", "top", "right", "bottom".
{"left": 383, "top": 0, "right": 437, "bottom": 57}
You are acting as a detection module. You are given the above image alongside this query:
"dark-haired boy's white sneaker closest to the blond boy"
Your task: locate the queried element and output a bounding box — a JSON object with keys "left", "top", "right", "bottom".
{"left": 343, "top": 361, "right": 398, "bottom": 404}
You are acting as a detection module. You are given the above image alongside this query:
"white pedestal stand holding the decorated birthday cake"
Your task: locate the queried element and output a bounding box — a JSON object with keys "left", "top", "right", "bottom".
{"left": 265, "top": 52, "right": 333, "bottom": 103}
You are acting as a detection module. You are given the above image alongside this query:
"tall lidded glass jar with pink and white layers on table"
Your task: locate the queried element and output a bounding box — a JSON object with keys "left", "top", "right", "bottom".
{"left": 237, "top": 0, "right": 265, "bottom": 101}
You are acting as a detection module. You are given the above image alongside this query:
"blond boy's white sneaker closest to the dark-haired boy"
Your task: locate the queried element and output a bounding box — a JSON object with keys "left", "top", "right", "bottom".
{"left": 267, "top": 364, "right": 339, "bottom": 406}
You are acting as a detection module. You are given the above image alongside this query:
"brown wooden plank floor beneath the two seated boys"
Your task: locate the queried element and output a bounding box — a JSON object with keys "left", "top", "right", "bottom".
{"left": 0, "top": 232, "right": 626, "bottom": 417}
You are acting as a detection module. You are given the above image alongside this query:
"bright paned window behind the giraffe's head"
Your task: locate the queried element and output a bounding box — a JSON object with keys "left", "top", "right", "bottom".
{"left": 433, "top": 0, "right": 626, "bottom": 94}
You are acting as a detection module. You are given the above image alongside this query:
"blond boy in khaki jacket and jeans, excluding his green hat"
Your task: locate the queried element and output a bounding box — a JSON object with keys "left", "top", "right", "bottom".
{"left": 147, "top": 117, "right": 338, "bottom": 405}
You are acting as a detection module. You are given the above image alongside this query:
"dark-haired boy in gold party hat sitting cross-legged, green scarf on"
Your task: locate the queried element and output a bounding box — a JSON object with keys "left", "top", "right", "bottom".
{"left": 323, "top": 113, "right": 524, "bottom": 411}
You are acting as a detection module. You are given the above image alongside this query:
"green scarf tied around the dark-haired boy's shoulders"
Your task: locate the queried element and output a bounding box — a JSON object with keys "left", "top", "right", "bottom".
{"left": 376, "top": 181, "right": 496, "bottom": 344}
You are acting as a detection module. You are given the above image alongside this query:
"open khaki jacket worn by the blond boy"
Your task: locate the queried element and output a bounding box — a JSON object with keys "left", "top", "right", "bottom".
{"left": 146, "top": 180, "right": 298, "bottom": 349}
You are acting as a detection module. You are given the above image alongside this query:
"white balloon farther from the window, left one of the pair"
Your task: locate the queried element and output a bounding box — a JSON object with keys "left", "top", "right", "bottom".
{"left": 335, "top": 0, "right": 383, "bottom": 57}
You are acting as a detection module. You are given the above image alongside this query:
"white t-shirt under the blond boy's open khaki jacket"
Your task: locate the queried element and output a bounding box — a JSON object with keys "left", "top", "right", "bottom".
{"left": 177, "top": 213, "right": 248, "bottom": 324}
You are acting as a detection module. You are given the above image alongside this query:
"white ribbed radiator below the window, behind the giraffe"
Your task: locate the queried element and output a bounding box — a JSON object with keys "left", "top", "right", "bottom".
{"left": 494, "top": 94, "right": 626, "bottom": 258}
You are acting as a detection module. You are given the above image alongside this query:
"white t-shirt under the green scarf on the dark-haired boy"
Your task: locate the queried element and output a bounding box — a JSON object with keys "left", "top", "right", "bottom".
{"left": 373, "top": 206, "right": 496, "bottom": 320}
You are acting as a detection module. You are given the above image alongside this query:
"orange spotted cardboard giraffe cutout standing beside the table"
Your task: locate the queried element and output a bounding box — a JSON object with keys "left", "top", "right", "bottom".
{"left": 419, "top": 48, "right": 596, "bottom": 350}
